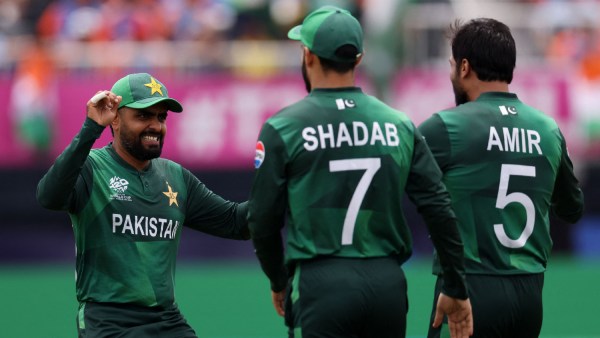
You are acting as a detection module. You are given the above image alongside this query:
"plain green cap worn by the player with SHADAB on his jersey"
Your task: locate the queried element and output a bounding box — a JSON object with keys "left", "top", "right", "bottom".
{"left": 288, "top": 6, "right": 363, "bottom": 62}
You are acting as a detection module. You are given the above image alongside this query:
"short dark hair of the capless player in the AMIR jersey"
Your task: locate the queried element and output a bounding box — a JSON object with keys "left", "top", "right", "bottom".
{"left": 449, "top": 18, "right": 517, "bottom": 83}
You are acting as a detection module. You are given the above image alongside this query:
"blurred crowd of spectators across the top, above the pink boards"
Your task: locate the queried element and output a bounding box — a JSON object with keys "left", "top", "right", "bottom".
{"left": 0, "top": 0, "right": 600, "bottom": 72}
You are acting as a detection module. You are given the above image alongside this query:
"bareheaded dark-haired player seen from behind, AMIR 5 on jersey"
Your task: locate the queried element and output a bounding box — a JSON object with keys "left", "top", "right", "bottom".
{"left": 419, "top": 18, "right": 583, "bottom": 338}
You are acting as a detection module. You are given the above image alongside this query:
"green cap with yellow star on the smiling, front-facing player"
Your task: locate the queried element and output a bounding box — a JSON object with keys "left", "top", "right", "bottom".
{"left": 111, "top": 73, "right": 183, "bottom": 113}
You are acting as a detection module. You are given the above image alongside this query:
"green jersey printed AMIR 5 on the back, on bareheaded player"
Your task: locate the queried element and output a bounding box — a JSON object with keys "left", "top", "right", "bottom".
{"left": 419, "top": 92, "right": 583, "bottom": 274}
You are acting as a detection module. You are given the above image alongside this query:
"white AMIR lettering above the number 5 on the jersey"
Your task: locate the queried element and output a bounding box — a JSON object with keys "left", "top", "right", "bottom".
{"left": 487, "top": 126, "right": 542, "bottom": 155}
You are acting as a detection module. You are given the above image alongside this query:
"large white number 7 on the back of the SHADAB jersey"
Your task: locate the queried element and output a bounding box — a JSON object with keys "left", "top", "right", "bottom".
{"left": 329, "top": 158, "right": 381, "bottom": 245}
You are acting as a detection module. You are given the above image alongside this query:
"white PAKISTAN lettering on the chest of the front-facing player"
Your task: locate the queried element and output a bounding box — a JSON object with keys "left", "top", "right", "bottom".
{"left": 112, "top": 214, "right": 179, "bottom": 239}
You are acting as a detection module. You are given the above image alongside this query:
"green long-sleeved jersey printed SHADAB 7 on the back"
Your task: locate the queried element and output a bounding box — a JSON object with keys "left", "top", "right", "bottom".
{"left": 248, "top": 87, "right": 466, "bottom": 295}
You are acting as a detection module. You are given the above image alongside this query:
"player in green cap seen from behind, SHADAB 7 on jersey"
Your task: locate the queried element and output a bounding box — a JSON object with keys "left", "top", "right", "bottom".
{"left": 248, "top": 6, "right": 472, "bottom": 338}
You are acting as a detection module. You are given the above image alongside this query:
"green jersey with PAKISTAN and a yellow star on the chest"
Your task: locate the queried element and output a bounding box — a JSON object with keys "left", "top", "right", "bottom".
{"left": 37, "top": 119, "right": 249, "bottom": 307}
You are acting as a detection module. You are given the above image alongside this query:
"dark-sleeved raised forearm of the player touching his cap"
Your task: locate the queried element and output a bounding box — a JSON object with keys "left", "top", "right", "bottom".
{"left": 36, "top": 119, "right": 104, "bottom": 210}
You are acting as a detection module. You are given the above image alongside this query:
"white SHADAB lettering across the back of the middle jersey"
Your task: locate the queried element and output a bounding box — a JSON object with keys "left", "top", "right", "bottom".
{"left": 302, "top": 121, "right": 400, "bottom": 151}
